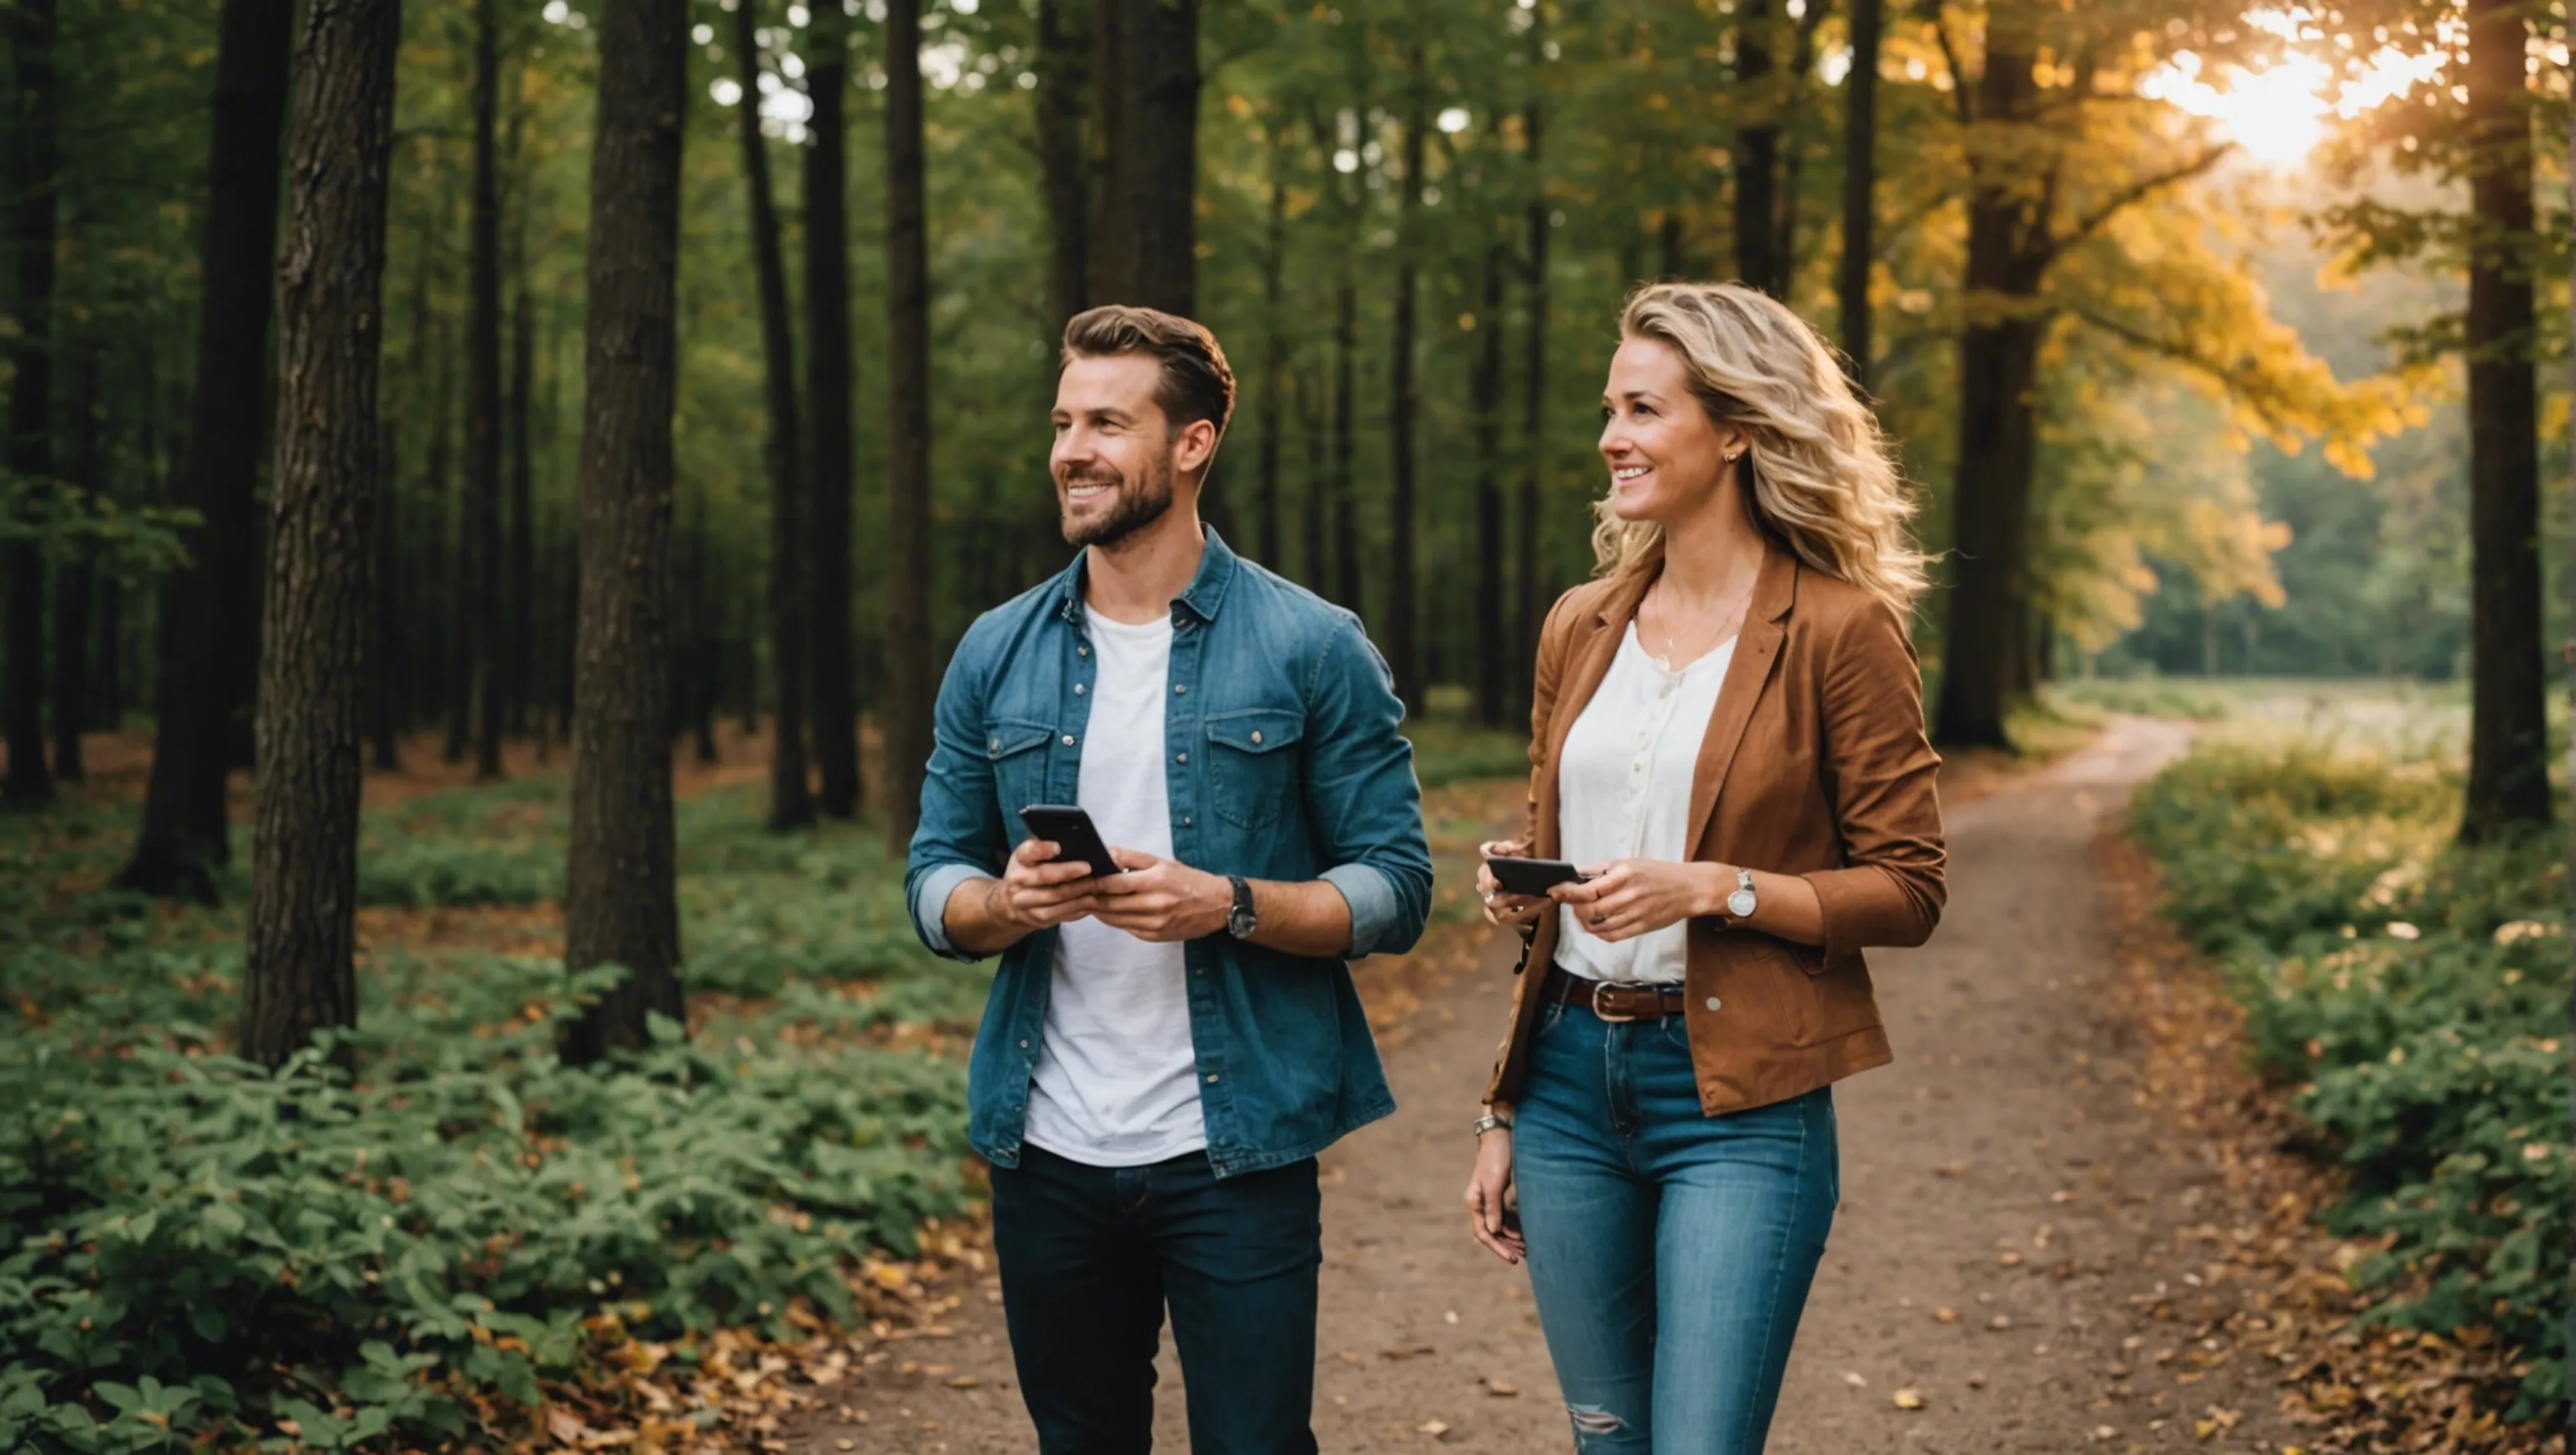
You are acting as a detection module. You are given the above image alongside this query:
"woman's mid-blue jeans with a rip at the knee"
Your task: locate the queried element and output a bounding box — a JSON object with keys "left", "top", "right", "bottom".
{"left": 1512, "top": 1005, "right": 1841, "bottom": 1455}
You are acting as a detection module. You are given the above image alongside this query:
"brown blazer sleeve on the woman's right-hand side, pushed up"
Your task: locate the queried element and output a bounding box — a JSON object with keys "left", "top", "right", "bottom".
{"left": 1805, "top": 600, "right": 1947, "bottom": 960}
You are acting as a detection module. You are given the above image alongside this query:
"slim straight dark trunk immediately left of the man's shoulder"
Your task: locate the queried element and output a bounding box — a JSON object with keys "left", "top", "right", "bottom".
{"left": 886, "top": 0, "right": 937, "bottom": 855}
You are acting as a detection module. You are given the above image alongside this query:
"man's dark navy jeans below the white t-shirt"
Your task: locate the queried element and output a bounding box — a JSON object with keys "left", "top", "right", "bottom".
{"left": 992, "top": 1146, "right": 1324, "bottom": 1455}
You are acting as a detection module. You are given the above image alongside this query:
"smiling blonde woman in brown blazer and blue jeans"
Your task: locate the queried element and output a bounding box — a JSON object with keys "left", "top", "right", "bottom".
{"left": 1466, "top": 283, "right": 1942, "bottom": 1455}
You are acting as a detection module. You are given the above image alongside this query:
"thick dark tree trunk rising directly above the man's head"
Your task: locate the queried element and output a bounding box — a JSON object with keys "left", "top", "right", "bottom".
{"left": 1093, "top": 0, "right": 1201, "bottom": 317}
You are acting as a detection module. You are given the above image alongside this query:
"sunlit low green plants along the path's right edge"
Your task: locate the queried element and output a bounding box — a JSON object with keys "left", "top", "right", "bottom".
{"left": 2131, "top": 739, "right": 2576, "bottom": 1419}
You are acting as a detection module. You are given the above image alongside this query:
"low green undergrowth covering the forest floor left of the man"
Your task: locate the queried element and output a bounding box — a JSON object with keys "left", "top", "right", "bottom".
{"left": 0, "top": 783, "right": 984, "bottom": 1452}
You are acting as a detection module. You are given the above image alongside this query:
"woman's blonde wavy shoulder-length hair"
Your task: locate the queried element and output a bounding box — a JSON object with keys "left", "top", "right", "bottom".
{"left": 1592, "top": 283, "right": 1929, "bottom": 613}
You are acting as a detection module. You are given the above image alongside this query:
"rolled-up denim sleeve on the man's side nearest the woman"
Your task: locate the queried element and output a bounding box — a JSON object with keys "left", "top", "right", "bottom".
{"left": 1306, "top": 618, "right": 1432, "bottom": 960}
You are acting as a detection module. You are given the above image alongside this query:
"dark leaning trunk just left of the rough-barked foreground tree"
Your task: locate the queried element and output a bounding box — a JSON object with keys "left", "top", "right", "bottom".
{"left": 121, "top": 0, "right": 296, "bottom": 870}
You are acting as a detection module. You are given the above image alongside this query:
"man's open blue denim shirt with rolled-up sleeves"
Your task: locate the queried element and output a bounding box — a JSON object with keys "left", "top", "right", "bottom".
{"left": 904, "top": 531, "right": 1432, "bottom": 1177}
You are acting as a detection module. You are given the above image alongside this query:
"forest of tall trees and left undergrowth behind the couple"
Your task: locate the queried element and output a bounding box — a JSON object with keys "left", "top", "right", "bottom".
{"left": 0, "top": 0, "right": 2576, "bottom": 1450}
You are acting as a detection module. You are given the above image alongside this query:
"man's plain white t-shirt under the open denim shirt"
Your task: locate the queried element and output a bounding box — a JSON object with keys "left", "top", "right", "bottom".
{"left": 1026, "top": 613, "right": 1208, "bottom": 1167}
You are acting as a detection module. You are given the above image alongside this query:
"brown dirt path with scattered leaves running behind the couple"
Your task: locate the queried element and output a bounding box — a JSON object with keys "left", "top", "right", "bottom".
{"left": 793, "top": 719, "right": 2295, "bottom": 1455}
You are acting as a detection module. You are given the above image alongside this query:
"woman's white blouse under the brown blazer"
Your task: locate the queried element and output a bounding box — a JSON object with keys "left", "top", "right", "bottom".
{"left": 1555, "top": 621, "right": 1737, "bottom": 986}
